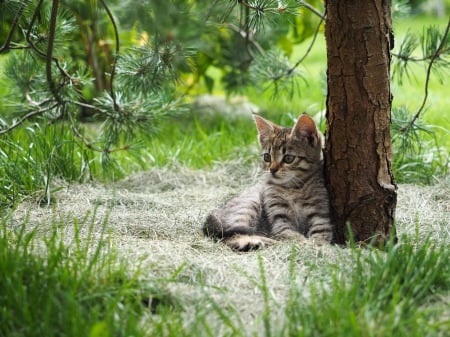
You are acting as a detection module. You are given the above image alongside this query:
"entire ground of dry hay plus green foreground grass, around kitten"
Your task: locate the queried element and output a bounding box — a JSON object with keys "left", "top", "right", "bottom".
{"left": 0, "top": 163, "right": 450, "bottom": 337}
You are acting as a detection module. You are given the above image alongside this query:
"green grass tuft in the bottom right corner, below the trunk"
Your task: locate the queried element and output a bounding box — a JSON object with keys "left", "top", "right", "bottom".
{"left": 280, "top": 237, "right": 450, "bottom": 337}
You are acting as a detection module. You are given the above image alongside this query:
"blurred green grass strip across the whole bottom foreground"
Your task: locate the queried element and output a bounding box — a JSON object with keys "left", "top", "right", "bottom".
{"left": 0, "top": 213, "right": 450, "bottom": 337}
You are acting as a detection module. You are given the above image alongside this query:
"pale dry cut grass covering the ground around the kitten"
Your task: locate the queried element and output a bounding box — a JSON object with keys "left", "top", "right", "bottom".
{"left": 12, "top": 163, "right": 450, "bottom": 329}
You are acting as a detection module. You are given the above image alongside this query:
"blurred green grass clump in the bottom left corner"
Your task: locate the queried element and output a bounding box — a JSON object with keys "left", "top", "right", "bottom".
{"left": 0, "top": 214, "right": 151, "bottom": 336}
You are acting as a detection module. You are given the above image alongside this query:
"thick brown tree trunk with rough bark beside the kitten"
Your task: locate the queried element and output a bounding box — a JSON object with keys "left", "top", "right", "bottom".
{"left": 325, "top": 0, "right": 397, "bottom": 245}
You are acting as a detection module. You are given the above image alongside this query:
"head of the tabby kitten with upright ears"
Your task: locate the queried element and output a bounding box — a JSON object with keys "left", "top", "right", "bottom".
{"left": 254, "top": 114, "right": 322, "bottom": 184}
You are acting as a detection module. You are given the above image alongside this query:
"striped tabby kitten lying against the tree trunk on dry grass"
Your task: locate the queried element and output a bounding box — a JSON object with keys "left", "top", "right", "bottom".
{"left": 203, "top": 114, "right": 333, "bottom": 251}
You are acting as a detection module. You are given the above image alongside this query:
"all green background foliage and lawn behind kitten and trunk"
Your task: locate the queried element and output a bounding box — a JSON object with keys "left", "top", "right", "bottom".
{"left": 0, "top": 0, "right": 450, "bottom": 206}
